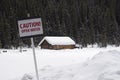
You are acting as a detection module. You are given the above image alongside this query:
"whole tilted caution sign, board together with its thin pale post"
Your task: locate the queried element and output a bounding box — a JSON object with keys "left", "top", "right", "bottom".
{"left": 18, "top": 16, "right": 43, "bottom": 80}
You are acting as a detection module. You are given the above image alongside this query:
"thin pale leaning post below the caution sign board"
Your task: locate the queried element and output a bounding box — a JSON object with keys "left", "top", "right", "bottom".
{"left": 31, "top": 37, "right": 39, "bottom": 80}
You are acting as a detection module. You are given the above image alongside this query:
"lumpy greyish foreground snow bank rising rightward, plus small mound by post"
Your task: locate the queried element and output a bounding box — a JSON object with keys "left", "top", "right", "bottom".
{"left": 22, "top": 51, "right": 120, "bottom": 80}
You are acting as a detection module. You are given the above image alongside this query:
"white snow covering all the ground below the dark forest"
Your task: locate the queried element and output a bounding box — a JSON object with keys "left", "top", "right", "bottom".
{"left": 0, "top": 46, "right": 120, "bottom": 80}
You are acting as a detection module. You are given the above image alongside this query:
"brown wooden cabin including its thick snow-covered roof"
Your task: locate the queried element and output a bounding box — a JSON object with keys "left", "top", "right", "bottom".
{"left": 39, "top": 36, "right": 75, "bottom": 50}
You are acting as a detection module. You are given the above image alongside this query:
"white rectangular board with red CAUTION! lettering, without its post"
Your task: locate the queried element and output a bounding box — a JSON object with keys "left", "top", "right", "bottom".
{"left": 18, "top": 18, "right": 43, "bottom": 37}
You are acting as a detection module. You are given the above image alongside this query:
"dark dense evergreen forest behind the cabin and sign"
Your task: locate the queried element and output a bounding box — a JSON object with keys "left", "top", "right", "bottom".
{"left": 0, "top": 0, "right": 120, "bottom": 48}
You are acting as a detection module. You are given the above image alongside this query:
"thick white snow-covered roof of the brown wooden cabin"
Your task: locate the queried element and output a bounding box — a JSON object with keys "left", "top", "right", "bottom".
{"left": 39, "top": 36, "right": 75, "bottom": 45}
